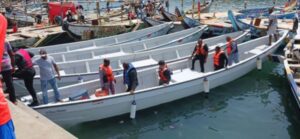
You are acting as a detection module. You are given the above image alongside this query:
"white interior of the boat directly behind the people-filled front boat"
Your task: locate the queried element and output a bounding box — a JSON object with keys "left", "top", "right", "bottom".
{"left": 32, "top": 31, "right": 248, "bottom": 76}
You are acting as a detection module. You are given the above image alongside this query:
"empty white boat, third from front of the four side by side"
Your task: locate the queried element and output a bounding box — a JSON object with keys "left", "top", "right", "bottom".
{"left": 41, "top": 26, "right": 207, "bottom": 63}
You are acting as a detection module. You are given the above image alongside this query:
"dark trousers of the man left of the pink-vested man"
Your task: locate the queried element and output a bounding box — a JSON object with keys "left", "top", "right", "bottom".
{"left": 1, "top": 70, "right": 16, "bottom": 102}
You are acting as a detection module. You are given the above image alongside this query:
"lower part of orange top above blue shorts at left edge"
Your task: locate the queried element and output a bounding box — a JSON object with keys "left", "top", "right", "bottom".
{"left": 0, "top": 83, "right": 11, "bottom": 126}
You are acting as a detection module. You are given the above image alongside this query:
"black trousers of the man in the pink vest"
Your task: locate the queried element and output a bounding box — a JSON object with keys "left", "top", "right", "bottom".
{"left": 14, "top": 68, "right": 37, "bottom": 101}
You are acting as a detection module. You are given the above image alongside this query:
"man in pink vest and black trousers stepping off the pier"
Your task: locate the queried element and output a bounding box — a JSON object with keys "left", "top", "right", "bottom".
{"left": 13, "top": 49, "right": 39, "bottom": 106}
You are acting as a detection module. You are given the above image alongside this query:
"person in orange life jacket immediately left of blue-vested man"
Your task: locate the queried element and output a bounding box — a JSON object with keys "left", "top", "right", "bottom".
{"left": 99, "top": 59, "right": 116, "bottom": 94}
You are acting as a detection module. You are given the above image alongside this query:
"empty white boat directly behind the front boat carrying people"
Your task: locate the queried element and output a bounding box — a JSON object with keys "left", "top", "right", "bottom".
{"left": 14, "top": 31, "right": 248, "bottom": 96}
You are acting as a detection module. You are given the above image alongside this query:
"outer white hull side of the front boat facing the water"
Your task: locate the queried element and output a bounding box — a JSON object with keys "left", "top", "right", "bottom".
{"left": 35, "top": 35, "right": 279, "bottom": 125}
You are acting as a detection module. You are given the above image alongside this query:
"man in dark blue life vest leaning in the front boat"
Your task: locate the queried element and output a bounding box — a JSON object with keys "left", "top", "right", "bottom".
{"left": 123, "top": 62, "right": 138, "bottom": 94}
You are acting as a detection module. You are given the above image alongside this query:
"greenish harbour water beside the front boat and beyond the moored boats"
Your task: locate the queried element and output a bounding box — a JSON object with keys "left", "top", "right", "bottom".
{"left": 61, "top": 0, "right": 300, "bottom": 139}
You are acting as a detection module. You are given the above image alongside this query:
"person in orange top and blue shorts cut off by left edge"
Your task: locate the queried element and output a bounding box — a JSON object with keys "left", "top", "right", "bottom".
{"left": 0, "top": 13, "right": 16, "bottom": 139}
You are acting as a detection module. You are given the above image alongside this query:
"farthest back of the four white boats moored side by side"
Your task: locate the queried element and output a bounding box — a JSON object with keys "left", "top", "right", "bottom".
{"left": 28, "top": 23, "right": 173, "bottom": 54}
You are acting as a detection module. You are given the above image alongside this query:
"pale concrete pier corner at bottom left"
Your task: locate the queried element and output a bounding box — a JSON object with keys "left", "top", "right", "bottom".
{"left": 9, "top": 102, "right": 76, "bottom": 139}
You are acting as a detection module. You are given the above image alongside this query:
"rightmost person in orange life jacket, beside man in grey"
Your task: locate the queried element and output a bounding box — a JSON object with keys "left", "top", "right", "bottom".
{"left": 213, "top": 46, "right": 228, "bottom": 71}
